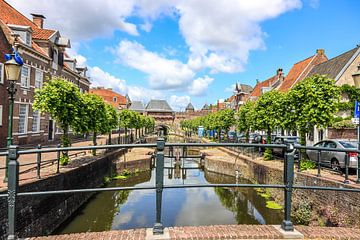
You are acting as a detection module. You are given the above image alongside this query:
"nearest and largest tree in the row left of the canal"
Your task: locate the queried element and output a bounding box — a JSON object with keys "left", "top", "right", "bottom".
{"left": 33, "top": 78, "right": 83, "bottom": 164}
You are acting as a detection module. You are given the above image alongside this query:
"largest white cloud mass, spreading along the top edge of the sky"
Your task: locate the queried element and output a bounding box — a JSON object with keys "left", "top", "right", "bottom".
{"left": 8, "top": 0, "right": 300, "bottom": 73}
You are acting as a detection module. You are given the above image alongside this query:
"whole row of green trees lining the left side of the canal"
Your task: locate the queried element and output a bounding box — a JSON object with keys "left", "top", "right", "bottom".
{"left": 33, "top": 78, "right": 155, "bottom": 163}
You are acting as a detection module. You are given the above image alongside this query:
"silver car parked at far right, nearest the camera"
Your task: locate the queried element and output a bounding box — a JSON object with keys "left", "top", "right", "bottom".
{"left": 306, "top": 140, "right": 358, "bottom": 171}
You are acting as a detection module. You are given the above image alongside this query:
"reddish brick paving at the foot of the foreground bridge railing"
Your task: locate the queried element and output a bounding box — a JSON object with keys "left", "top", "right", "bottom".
{"left": 31, "top": 225, "right": 360, "bottom": 240}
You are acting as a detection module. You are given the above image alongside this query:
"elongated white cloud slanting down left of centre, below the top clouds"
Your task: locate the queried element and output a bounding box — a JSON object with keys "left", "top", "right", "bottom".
{"left": 114, "top": 41, "right": 194, "bottom": 89}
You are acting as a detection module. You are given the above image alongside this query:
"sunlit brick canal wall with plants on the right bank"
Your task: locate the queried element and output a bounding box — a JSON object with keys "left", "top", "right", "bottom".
{"left": 205, "top": 150, "right": 360, "bottom": 227}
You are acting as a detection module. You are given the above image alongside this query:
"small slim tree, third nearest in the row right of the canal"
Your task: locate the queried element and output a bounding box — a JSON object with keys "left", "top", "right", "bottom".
{"left": 237, "top": 101, "right": 255, "bottom": 142}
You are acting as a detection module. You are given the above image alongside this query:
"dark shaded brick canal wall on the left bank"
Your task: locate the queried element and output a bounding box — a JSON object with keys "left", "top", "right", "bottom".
{"left": 0, "top": 149, "right": 127, "bottom": 239}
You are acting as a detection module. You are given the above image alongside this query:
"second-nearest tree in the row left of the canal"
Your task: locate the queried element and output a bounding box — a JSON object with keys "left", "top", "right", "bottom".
{"left": 82, "top": 93, "right": 109, "bottom": 155}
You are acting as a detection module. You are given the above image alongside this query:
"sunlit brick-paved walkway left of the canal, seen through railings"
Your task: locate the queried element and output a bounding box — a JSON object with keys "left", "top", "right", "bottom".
{"left": 0, "top": 133, "right": 134, "bottom": 191}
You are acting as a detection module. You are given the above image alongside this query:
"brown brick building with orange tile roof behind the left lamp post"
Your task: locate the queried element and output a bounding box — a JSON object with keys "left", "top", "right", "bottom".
{"left": 0, "top": 0, "right": 90, "bottom": 147}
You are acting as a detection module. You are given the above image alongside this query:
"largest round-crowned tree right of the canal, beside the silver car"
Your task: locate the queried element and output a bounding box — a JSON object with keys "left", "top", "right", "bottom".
{"left": 289, "top": 75, "right": 340, "bottom": 145}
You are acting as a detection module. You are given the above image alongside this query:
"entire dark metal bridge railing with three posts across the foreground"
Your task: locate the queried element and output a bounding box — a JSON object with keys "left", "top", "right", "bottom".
{"left": 0, "top": 138, "right": 360, "bottom": 239}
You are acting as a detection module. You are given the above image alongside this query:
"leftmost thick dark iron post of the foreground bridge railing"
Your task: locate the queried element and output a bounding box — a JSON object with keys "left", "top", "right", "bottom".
{"left": 7, "top": 145, "right": 19, "bottom": 240}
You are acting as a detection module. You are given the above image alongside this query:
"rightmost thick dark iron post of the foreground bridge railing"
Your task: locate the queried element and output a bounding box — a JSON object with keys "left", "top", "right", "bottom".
{"left": 281, "top": 144, "right": 294, "bottom": 231}
